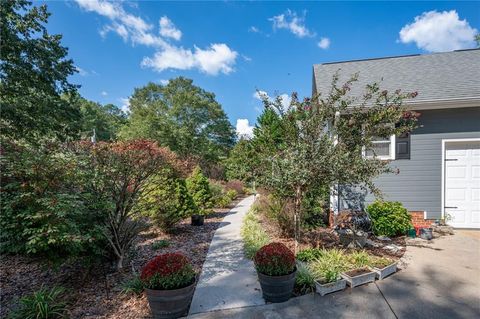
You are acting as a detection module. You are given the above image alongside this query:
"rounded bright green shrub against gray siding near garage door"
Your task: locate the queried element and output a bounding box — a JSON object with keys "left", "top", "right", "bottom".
{"left": 366, "top": 201, "right": 412, "bottom": 236}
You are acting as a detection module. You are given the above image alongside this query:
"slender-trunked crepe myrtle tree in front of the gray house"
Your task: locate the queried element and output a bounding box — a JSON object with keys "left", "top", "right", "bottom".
{"left": 253, "top": 74, "right": 418, "bottom": 249}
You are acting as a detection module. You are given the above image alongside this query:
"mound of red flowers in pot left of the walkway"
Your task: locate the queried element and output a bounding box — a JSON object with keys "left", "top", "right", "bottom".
{"left": 140, "top": 253, "right": 195, "bottom": 290}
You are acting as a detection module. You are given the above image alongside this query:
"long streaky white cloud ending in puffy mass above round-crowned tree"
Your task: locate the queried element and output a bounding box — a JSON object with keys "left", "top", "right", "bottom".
{"left": 76, "top": 0, "right": 238, "bottom": 75}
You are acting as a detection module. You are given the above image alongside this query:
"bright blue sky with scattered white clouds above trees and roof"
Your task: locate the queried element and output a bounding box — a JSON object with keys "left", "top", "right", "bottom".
{"left": 41, "top": 0, "right": 480, "bottom": 134}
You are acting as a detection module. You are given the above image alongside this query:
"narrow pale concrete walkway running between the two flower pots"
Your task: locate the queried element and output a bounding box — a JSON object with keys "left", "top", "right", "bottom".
{"left": 189, "top": 196, "right": 265, "bottom": 314}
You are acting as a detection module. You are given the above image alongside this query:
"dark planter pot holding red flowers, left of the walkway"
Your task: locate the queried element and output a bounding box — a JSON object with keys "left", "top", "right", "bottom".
{"left": 145, "top": 283, "right": 195, "bottom": 319}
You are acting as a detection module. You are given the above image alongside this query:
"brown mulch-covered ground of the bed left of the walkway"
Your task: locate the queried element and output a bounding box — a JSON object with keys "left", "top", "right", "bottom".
{"left": 0, "top": 198, "right": 246, "bottom": 319}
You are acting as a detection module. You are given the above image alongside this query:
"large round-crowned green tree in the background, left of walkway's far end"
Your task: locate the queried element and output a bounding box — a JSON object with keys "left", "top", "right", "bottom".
{"left": 121, "top": 77, "right": 235, "bottom": 165}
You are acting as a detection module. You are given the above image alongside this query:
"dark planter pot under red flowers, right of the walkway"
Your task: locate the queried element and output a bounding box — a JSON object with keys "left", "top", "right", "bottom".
{"left": 257, "top": 268, "right": 297, "bottom": 302}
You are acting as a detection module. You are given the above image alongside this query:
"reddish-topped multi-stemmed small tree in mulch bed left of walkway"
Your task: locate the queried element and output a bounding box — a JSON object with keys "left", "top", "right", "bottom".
{"left": 75, "top": 140, "right": 183, "bottom": 269}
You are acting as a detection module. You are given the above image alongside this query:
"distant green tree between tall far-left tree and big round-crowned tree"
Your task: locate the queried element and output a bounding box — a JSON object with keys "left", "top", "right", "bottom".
{"left": 75, "top": 97, "right": 127, "bottom": 141}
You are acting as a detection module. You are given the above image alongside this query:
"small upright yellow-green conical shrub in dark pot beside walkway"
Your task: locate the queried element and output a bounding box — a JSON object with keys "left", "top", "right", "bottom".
{"left": 186, "top": 166, "right": 213, "bottom": 215}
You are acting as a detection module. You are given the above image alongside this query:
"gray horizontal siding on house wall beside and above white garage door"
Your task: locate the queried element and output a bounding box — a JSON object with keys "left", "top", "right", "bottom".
{"left": 366, "top": 107, "right": 480, "bottom": 219}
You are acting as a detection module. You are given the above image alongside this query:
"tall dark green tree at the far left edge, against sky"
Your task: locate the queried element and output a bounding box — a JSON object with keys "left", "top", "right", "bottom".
{"left": 0, "top": 0, "right": 80, "bottom": 140}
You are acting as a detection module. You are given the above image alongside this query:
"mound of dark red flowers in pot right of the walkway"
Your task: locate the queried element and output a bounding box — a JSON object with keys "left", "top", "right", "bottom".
{"left": 254, "top": 243, "right": 295, "bottom": 276}
